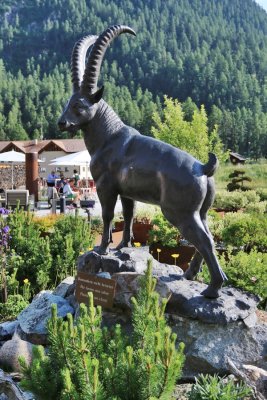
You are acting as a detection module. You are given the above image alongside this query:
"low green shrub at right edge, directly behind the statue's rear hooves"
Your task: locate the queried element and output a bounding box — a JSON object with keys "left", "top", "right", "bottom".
{"left": 199, "top": 248, "right": 267, "bottom": 307}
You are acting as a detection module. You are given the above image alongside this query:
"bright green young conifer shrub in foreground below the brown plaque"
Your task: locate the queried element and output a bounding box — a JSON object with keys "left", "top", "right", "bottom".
{"left": 20, "top": 263, "right": 184, "bottom": 400}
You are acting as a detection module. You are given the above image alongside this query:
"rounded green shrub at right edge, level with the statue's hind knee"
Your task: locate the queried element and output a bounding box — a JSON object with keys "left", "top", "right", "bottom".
{"left": 222, "top": 213, "right": 267, "bottom": 251}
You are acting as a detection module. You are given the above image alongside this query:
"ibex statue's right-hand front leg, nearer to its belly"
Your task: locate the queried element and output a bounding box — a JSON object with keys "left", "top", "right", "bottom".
{"left": 117, "top": 197, "right": 135, "bottom": 250}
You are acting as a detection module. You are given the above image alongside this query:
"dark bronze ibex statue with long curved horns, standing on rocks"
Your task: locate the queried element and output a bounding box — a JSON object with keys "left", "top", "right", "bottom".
{"left": 58, "top": 25, "right": 226, "bottom": 298}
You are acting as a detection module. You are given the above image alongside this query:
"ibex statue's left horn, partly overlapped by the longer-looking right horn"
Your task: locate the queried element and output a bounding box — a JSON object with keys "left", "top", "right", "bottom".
{"left": 71, "top": 35, "right": 97, "bottom": 92}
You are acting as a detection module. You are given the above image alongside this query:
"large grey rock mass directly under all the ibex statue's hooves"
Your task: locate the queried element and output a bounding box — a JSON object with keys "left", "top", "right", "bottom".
{"left": 74, "top": 248, "right": 267, "bottom": 377}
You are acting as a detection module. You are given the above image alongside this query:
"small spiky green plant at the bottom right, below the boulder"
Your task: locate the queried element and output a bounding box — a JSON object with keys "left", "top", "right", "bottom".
{"left": 189, "top": 375, "right": 252, "bottom": 400}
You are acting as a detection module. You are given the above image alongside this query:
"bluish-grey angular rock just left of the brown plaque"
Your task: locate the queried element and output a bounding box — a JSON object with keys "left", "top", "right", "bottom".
{"left": 18, "top": 291, "right": 74, "bottom": 344}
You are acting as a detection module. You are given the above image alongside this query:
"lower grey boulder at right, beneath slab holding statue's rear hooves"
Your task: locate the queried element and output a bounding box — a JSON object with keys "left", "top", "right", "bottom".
{"left": 168, "top": 314, "right": 267, "bottom": 377}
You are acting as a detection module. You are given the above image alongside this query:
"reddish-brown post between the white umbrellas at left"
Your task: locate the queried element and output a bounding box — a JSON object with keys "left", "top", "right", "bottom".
{"left": 25, "top": 152, "right": 39, "bottom": 203}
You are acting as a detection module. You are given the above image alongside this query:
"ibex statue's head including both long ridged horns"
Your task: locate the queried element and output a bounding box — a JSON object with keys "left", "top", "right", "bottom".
{"left": 58, "top": 25, "right": 135, "bottom": 133}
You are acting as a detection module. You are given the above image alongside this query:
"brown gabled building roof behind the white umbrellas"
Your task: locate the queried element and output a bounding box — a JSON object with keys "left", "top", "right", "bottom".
{"left": 0, "top": 139, "right": 86, "bottom": 153}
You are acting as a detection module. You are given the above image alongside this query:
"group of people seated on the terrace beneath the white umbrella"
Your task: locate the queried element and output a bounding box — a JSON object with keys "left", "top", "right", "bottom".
{"left": 47, "top": 169, "right": 80, "bottom": 207}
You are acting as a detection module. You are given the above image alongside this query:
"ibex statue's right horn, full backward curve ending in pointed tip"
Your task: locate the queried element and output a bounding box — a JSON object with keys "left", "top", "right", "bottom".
{"left": 81, "top": 25, "right": 136, "bottom": 95}
